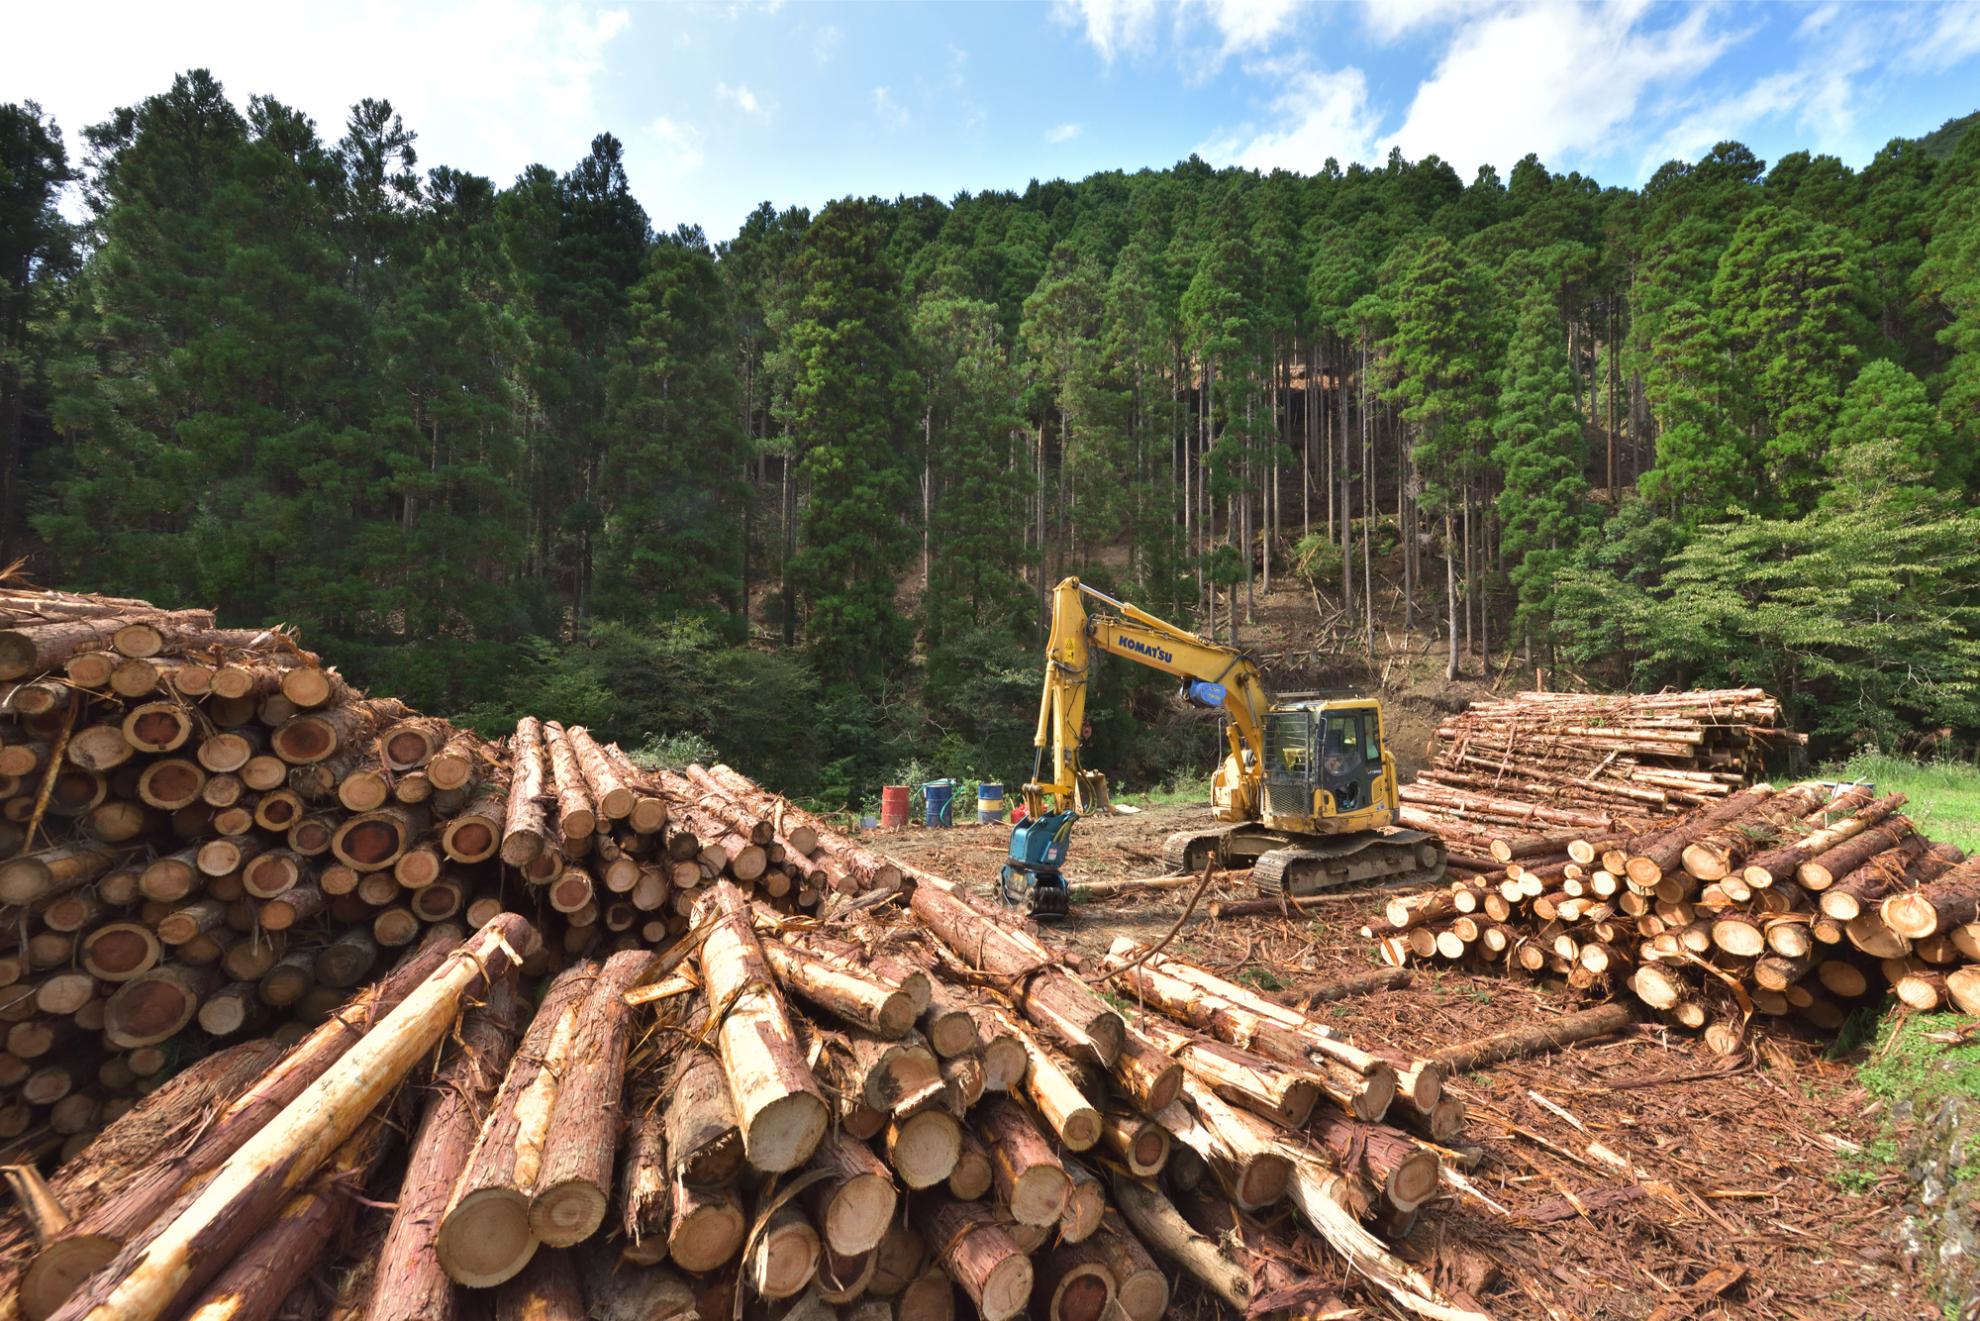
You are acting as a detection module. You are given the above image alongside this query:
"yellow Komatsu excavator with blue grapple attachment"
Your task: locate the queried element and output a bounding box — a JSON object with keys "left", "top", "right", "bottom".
{"left": 1002, "top": 578, "right": 1443, "bottom": 917}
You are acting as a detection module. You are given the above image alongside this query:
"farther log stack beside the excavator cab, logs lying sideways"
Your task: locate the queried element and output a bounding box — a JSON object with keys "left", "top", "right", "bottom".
{"left": 1402, "top": 687, "right": 1800, "bottom": 848}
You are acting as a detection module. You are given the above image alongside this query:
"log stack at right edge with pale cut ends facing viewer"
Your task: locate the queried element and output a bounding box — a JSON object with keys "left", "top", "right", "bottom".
{"left": 1368, "top": 782, "right": 1980, "bottom": 1050}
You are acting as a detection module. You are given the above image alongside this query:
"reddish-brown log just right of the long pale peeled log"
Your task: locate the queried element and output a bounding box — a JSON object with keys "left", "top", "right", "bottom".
{"left": 364, "top": 972, "right": 521, "bottom": 1321}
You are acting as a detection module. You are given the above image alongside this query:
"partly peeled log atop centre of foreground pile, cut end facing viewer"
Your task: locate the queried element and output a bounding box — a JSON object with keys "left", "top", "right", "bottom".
{"left": 695, "top": 881, "right": 828, "bottom": 1174}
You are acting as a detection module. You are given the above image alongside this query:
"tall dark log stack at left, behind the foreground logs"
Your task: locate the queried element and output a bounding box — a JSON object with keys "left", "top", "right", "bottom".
{"left": 0, "top": 590, "right": 899, "bottom": 1161}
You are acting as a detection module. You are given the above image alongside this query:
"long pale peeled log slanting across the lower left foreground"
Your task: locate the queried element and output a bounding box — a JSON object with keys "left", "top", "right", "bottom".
{"left": 55, "top": 913, "right": 535, "bottom": 1321}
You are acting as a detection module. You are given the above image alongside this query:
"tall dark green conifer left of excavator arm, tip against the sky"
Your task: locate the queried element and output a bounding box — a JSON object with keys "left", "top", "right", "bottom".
{"left": 786, "top": 200, "right": 921, "bottom": 689}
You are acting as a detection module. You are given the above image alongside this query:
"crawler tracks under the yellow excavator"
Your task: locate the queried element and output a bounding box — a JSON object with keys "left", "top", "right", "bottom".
{"left": 1162, "top": 826, "right": 1445, "bottom": 899}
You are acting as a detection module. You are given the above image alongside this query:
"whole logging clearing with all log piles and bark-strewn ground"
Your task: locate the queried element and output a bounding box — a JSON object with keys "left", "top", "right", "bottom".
{"left": 0, "top": 588, "right": 1980, "bottom": 1321}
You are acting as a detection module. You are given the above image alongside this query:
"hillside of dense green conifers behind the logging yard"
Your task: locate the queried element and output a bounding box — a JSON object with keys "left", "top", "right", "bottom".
{"left": 0, "top": 71, "right": 1980, "bottom": 802}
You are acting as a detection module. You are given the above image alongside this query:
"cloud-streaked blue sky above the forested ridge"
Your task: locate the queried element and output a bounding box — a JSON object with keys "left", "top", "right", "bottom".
{"left": 15, "top": 0, "right": 1980, "bottom": 240}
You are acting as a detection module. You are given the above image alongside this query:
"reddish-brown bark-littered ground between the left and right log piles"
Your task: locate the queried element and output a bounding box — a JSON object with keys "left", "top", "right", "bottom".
{"left": 881, "top": 808, "right": 1940, "bottom": 1321}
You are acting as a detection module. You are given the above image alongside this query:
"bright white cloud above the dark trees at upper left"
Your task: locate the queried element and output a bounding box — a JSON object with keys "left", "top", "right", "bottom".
{"left": 0, "top": 0, "right": 632, "bottom": 184}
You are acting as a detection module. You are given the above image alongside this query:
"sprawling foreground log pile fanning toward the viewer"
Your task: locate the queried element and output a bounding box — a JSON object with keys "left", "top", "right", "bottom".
{"left": 0, "top": 873, "right": 1481, "bottom": 1321}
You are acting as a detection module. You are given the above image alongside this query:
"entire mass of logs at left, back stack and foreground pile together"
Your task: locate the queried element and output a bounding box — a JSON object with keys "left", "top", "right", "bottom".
{"left": 0, "top": 590, "right": 1477, "bottom": 1321}
